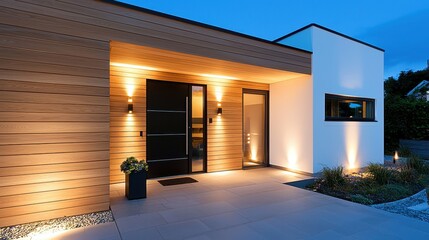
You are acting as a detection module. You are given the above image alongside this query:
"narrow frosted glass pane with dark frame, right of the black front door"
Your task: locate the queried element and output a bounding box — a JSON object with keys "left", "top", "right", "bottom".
{"left": 243, "top": 90, "right": 268, "bottom": 168}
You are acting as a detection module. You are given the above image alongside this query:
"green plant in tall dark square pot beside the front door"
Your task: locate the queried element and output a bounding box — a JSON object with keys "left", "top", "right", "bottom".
{"left": 121, "top": 157, "right": 148, "bottom": 200}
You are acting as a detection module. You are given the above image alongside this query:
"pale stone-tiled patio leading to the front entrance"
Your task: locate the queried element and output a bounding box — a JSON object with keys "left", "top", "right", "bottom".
{"left": 54, "top": 168, "right": 429, "bottom": 240}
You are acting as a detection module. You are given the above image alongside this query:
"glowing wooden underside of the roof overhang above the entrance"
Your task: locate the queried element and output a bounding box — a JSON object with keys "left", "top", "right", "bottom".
{"left": 110, "top": 41, "right": 308, "bottom": 84}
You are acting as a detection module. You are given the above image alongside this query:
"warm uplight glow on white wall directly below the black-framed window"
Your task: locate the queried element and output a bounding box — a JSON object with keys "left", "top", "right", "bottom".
{"left": 344, "top": 123, "right": 360, "bottom": 170}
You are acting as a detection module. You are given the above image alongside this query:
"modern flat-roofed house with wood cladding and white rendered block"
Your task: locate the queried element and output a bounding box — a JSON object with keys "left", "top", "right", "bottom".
{"left": 0, "top": 0, "right": 383, "bottom": 226}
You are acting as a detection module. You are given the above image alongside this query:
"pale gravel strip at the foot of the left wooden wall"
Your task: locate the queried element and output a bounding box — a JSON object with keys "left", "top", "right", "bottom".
{"left": 0, "top": 211, "right": 114, "bottom": 240}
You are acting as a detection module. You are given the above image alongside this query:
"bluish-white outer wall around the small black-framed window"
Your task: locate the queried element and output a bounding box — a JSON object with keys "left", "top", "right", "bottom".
{"left": 312, "top": 27, "right": 384, "bottom": 172}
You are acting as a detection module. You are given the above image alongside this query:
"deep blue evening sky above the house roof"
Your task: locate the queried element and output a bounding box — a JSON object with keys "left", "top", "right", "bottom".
{"left": 122, "top": 0, "right": 429, "bottom": 78}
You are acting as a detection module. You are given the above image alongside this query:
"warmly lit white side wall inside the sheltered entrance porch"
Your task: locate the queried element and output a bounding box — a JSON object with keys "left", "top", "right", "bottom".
{"left": 269, "top": 76, "right": 313, "bottom": 173}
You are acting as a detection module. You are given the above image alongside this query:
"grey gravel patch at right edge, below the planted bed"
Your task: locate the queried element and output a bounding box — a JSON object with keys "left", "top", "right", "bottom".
{"left": 372, "top": 189, "right": 429, "bottom": 222}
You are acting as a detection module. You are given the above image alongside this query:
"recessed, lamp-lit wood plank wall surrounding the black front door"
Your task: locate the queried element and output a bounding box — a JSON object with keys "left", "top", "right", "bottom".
{"left": 110, "top": 66, "right": 269, "bottom": 183}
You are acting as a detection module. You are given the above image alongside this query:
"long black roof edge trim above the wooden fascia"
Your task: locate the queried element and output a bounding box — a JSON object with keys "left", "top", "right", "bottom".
{"left": 103, "top": 0, "right": 313, "bottom": 53}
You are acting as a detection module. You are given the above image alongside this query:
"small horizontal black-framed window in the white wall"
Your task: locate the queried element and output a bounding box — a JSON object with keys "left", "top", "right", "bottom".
{"left": 325, "top": 94, "right": 375, "bottom": 121}
